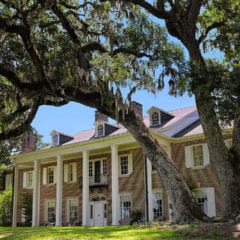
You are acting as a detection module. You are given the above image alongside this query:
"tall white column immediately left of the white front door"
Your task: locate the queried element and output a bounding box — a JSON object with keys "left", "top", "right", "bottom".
{"left": 82, "top": 151, "right": 89, "bottom": 226}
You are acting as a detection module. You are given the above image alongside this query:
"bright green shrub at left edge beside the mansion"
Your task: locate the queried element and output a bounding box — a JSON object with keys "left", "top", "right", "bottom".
{"left": 0, "top": 185, "right": 12, "bottom": 226}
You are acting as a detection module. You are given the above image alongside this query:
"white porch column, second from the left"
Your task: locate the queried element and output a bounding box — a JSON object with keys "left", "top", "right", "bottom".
{"left": 32, "top": 159, "right": 40, "bottom": 227}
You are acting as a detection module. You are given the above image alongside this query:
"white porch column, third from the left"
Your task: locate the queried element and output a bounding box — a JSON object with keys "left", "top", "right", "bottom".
{"left": 55, "top": 154, "right": 63, "bottom": 226}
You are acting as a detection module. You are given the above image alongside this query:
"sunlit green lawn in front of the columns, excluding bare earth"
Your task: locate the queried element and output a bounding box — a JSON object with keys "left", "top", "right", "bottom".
{"left": 0, "top": 226, "right": 179, "bottom": 240}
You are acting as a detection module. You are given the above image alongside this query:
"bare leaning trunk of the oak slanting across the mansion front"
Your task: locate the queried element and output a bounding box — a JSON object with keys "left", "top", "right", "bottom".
{"left": 99, "top": 108, "right": 207, "bottom": 224}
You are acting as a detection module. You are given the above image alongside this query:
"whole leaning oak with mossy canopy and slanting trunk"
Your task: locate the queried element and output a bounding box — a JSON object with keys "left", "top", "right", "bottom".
{"left": 0, "top": 0, "right": 204, "bottom": 222}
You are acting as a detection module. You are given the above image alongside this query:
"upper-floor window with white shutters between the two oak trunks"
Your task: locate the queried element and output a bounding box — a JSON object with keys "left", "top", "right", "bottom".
{"left": 185, "top": 144, "right": 210, "bottom": 168}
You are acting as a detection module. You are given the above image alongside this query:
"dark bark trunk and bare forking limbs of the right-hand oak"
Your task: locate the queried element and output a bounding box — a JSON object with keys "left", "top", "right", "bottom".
{"left": 130, "top": 0, "right": 240, "bottom": 218}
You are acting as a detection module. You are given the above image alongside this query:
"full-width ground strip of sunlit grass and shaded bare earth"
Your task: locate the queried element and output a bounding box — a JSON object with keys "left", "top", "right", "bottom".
{"left": 0, "top": 222, "right": 240, "bottom": 240}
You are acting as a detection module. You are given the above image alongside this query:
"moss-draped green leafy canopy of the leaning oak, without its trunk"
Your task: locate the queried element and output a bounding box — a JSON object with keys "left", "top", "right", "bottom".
{"left": 0, "top": 0, "right": 184, "bottom": 139}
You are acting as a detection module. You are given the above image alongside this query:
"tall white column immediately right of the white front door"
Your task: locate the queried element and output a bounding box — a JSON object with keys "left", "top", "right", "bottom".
{"left": 111, "top": 145, "right": 120, "bottom": 225}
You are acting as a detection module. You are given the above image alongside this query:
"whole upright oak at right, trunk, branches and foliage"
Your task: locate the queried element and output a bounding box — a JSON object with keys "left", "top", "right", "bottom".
{"left": 116, "top": 0, "right": 240, "bottom": 218}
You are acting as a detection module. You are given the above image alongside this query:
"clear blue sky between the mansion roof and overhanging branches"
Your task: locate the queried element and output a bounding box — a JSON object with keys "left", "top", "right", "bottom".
{"left": 32, "top": 90, "right": 195, "bottom": 143}
